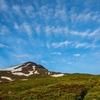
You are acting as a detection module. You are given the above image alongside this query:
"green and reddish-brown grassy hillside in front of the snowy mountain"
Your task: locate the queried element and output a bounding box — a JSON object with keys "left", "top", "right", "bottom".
{"left": 0, "top": 74, "right": 100, "bottom": 100}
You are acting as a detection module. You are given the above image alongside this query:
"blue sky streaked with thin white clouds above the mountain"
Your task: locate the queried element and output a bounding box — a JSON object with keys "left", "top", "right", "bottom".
{"left": 0, "top": 0, "right": 100, "bottom": 74}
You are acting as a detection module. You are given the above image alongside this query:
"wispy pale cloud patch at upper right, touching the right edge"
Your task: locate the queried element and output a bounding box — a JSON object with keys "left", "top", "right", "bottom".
{"left": 68, "top": 7, "right": 100, "bottom": 24}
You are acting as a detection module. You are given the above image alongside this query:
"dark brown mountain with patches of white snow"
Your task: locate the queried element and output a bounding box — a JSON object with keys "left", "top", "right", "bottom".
{"left": 0, "top": 62, "right": 65, "bottom": 82}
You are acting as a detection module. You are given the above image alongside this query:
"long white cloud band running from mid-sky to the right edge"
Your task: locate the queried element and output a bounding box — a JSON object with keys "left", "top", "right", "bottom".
{"left": 44, "top": 26, "right": 100, "bottom": 38}
